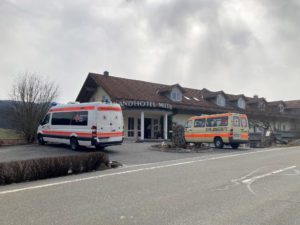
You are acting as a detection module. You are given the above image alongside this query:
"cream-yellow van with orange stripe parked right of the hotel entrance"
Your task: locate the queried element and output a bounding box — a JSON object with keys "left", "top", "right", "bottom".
{"left": 184, "top": 113, "right": 249, "bottom": 149}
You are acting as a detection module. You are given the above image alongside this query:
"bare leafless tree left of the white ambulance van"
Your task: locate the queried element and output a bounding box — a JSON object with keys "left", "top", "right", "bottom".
{"left": 10, "top": 73, "right": 58, "bottom": 143}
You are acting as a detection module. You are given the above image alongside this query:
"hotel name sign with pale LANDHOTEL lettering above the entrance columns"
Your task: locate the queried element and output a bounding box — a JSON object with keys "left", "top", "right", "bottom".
{"left": 117, "top": 100, "right": 172, "bottom": 110}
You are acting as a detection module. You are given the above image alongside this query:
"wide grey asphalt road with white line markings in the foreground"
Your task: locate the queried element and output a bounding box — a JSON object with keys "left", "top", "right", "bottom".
{"left": 0, "top": 147, "right": 300, "bottom": 225}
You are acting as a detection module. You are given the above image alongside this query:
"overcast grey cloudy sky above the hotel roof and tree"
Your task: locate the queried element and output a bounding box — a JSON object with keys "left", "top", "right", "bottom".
{"left": 0, "top": 0, "right": 300, "bottom": 102}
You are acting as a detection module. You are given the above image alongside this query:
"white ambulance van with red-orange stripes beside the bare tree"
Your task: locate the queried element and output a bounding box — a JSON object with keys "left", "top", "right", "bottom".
{"left": 37, "top": 102, "right": 124, "bottom": 150}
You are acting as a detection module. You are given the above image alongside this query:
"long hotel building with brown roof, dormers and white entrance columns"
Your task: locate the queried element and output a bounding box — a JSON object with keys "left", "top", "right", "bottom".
{"left": 76, "top": 72, "right": 300, "bottom": 140}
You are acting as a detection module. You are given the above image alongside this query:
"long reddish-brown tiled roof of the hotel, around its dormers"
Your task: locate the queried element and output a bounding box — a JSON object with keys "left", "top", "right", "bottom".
{"left": 76, "top": 73, "right": 300, "bottom": 118}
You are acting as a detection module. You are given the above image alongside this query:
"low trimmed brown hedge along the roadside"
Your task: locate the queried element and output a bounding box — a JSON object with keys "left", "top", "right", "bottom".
{"left": 0, "top": 152, "right": 109, "bottom": 185}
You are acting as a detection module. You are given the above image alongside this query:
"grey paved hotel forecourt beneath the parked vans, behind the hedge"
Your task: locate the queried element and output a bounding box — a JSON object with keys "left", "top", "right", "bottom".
{"left": 0, "top": 142, "right": 241, "bottom": 166}
